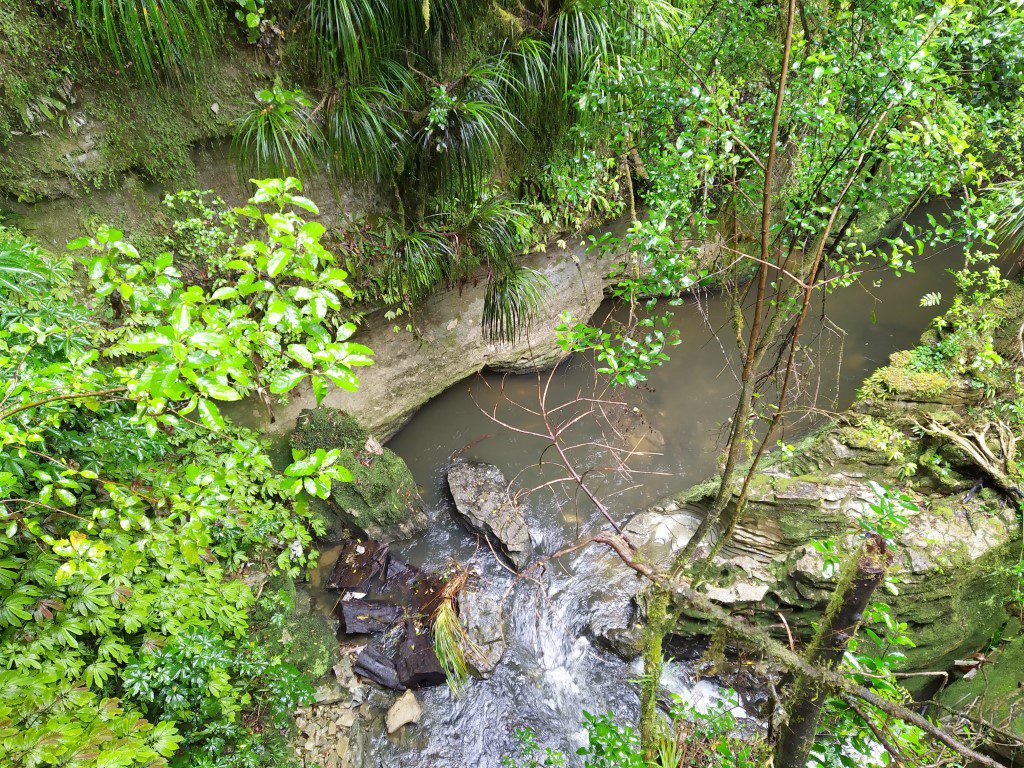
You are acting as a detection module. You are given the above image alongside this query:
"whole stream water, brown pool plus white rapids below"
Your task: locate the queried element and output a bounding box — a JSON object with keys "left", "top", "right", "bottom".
{"left": 362, "top": 201, "right": 974, "bottom": 768}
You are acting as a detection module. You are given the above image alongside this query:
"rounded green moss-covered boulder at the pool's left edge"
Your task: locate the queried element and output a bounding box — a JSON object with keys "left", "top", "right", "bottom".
{"left": 292, "top": 408, "right": 426, "bottom": 541}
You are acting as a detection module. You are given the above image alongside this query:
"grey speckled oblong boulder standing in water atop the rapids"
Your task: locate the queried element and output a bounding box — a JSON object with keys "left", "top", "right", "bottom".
{"left": 447, "top": 460, "right": 531, "bottom": 570}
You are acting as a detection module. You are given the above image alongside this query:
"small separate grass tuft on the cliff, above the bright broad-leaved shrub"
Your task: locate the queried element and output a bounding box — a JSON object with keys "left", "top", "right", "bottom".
{"left": 231, "top": 85, "right": 325, "bottom": 180}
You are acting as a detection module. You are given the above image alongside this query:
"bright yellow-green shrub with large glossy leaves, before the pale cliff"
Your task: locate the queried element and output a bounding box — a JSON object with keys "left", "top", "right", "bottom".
{"left": 69, "top": 178, "right": 373, "bottom": 434}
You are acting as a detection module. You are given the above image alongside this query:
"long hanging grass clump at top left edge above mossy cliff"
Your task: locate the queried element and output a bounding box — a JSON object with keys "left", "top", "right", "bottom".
{"left": 70, "top": 0, "right": 217, "bottom": 84}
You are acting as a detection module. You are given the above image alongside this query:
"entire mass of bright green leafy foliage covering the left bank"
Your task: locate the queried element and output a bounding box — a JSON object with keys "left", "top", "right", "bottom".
{"left": 0, "top": 180, "right": 370, "bottom": 768}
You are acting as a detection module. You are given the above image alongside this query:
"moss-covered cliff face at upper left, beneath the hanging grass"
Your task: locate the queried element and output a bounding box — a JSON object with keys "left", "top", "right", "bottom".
{"left": 0, "top": 22, "right": 267, "bottom": 202}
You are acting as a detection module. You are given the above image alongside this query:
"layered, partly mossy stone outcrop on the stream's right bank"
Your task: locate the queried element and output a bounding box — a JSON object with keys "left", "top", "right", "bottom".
{"left": 606, "top": 326, "right": 1019, "bottom": 689}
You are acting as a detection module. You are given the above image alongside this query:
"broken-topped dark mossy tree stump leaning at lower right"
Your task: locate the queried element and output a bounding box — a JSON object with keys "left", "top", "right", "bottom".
{"left": 775, "top": 537, "right": 891, "bottom": 768}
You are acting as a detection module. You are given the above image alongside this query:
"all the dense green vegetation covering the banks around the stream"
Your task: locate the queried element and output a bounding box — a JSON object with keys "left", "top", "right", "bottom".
{"left": 0, "top": 0, "right": 1024, "bottom": 768}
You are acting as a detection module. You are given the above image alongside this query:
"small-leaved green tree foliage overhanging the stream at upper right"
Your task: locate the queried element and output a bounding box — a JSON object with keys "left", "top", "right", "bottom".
{"left": 566, "top": 0, "right": 1024, "bottom": 380}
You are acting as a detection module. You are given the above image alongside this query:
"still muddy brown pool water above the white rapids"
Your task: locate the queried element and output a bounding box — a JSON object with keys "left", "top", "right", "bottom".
{"left": 388, "top": 203, "right": 963, "bottom": 563}
